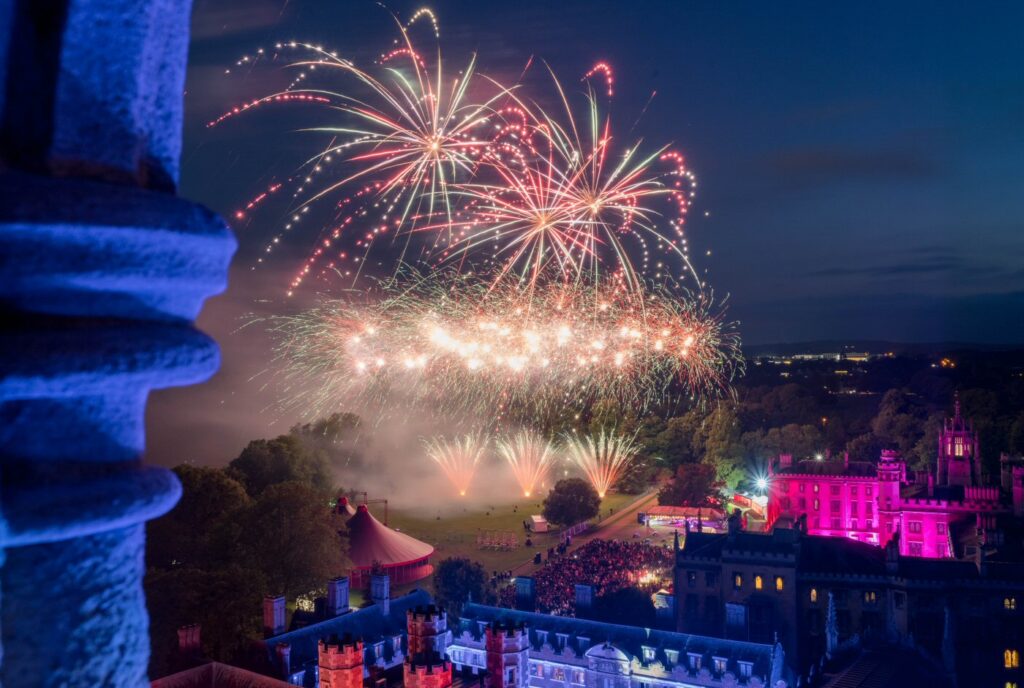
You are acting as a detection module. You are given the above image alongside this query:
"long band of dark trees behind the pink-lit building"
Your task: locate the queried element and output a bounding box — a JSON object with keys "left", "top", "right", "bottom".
{"left": 565, "top": 353, "right": 1024, "bottom": 504}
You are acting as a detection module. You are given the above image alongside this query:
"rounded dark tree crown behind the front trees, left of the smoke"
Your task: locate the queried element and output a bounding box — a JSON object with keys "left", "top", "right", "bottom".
{"left": 227, "top": 434, "right": 332, "bottom": 497}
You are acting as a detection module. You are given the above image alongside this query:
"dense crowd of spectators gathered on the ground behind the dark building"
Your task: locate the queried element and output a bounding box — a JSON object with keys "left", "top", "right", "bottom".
{"left": 501, "top": 540, "right": 673, "bottom": 615}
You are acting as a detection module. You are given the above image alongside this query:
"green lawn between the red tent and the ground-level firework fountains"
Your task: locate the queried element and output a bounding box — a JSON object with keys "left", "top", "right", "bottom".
{"left": 385, "top": 493, "right": 637, "bottom": 588}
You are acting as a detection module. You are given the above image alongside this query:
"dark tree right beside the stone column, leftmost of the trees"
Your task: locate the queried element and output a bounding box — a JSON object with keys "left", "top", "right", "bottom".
{"left": 146, "top": 464, "right": 252, "bottom": 568}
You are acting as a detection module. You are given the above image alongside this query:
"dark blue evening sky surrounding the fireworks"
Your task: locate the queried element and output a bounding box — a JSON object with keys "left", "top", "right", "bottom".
{"left": 148, "top": 0, "right": 1024, "bottom": 465}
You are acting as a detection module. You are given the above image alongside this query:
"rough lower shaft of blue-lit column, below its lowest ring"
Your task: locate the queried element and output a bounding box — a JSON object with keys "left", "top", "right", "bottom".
{"left": 0, "top": 525, "right": 150, "bottom": 688}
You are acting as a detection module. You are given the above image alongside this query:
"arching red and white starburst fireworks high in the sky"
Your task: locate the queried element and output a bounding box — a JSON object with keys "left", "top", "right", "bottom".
{"left": 209, "top": 9, "right": 702, "bottom": 297}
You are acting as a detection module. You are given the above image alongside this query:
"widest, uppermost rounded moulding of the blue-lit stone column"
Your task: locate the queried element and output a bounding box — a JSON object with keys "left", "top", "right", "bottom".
{"left": 0, "top": 174, "right": 236, "bottom": 320}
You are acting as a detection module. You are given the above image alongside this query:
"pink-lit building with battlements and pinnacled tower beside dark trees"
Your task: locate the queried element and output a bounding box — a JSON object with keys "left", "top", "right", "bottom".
{"left": 767, "top": 401, "right": 1024, "bottom": 559}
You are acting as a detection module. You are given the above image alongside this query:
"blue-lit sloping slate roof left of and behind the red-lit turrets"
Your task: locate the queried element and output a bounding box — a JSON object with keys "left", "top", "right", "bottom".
{"left": 266, "top": 590, "right": 433, "bottom": 668}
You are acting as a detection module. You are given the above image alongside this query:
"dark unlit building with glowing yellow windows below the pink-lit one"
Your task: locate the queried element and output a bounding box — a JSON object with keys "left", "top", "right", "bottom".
{"left": 675, "top": 519, "right": 1024, "bottom": 686}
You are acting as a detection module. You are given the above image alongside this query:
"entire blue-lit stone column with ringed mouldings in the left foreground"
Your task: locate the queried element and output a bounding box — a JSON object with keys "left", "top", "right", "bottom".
{"left": 0, "top": 0, "right": 234, "bottom": 688}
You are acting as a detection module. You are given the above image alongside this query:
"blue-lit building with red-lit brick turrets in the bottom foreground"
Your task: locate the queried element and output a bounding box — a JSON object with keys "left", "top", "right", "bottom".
{"left": 243, "top": 575, "right": 792, "bottom": 688}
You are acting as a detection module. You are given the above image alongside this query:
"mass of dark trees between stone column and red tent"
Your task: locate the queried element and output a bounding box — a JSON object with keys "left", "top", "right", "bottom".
{"left": 144, "top": 416, "right": 352, "bottom": 677}
